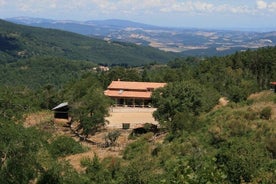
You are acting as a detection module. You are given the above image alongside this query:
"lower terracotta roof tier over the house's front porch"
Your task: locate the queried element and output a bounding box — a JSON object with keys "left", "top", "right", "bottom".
{"left": 104, "top": 90, "right": 151, "bottom": 99}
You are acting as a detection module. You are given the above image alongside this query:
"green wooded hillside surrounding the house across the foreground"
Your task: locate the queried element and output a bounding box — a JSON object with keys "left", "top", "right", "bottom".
{"left": 0, "top": 33, "right": 276, "bottom": 184}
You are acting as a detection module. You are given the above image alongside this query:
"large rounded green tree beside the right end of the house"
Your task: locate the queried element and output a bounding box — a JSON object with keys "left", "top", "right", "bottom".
{"left": 152, "top": 81, "right": 219, "bottom": 129}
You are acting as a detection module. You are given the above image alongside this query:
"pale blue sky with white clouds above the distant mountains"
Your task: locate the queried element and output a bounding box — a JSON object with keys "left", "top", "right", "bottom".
{"left": 0, "top": 0, "right": 276, "bottom": 30}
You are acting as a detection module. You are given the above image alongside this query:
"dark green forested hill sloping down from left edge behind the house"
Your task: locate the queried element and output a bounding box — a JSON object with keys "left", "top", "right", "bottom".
{"left": 0, "top": 20, "right": 177, "bottom": 65}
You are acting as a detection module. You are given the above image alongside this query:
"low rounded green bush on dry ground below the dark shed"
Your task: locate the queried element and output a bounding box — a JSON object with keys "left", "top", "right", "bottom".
{"left": 49, "top": 136, "right": 84, "bottom": 157}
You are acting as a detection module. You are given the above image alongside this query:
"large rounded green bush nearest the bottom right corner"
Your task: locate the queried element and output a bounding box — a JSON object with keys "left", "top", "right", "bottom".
{"left": 217, "top": 138, "right": 269, "bottom": 183}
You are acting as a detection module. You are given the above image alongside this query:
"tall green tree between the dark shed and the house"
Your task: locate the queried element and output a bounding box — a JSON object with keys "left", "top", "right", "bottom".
{"left": 63, "top": 74, "right": 110, "bottom": 135}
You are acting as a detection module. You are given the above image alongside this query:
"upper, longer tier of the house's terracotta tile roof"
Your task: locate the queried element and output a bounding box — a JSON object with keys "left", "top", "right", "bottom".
{"left": 107, "top": 81, "right": 166, "bottom": 91}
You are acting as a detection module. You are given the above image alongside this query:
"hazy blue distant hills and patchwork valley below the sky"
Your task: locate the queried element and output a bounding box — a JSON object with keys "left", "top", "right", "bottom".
{"left": 6, "top": 17, "right": 276, "bottom": 56}
